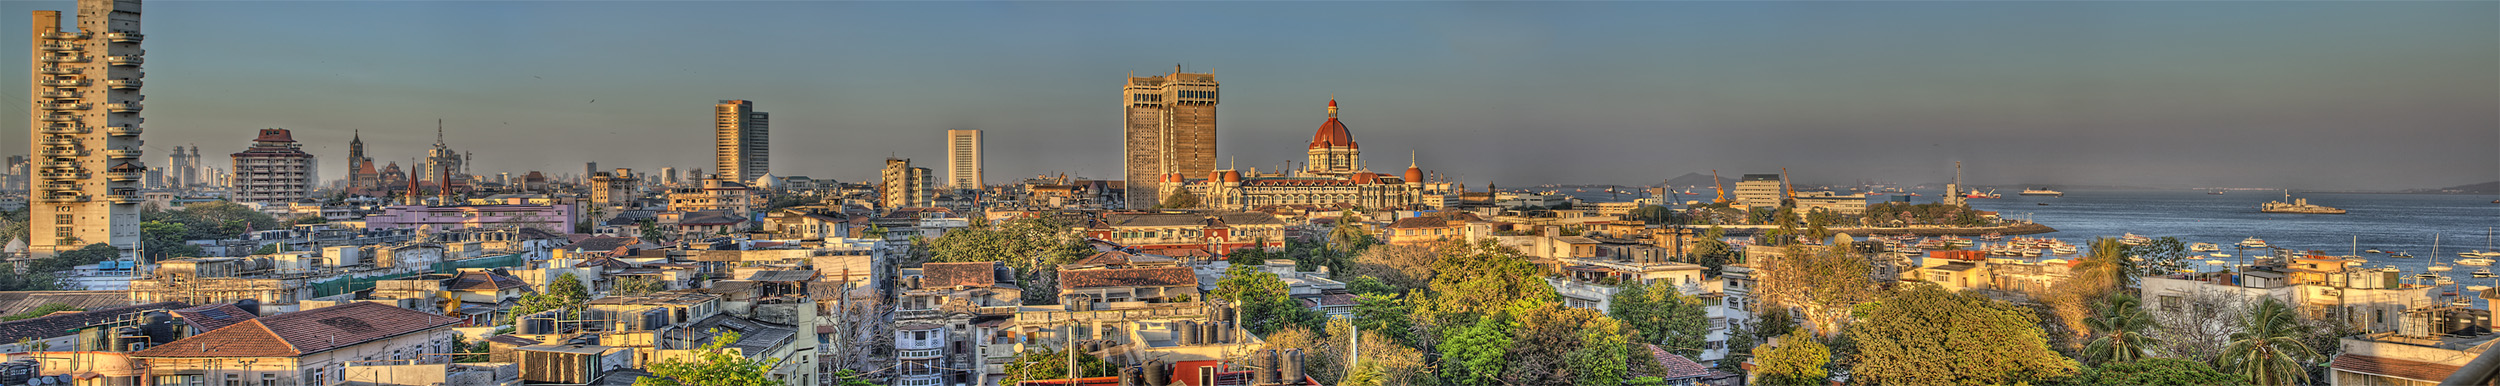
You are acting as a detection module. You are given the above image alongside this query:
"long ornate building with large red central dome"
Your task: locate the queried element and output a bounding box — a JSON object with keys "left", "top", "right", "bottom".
{"left": 1160, "top": 100, "right": 1455, "bottom": 211}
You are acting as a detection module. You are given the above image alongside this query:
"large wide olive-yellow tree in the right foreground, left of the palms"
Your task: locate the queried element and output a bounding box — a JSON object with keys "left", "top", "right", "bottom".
{"left": 1848, "top": 283, "right": 2075, "bottom": 386}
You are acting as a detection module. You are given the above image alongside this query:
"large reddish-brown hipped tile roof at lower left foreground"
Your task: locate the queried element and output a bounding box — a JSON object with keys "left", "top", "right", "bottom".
{"left": 130, "top": 301, "right": 458, "bottom": 358}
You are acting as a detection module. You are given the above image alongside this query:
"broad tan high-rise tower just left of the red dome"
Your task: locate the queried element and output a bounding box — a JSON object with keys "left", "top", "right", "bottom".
{"left": 1120, "top": 68, "right": 1220, "bottom": 208}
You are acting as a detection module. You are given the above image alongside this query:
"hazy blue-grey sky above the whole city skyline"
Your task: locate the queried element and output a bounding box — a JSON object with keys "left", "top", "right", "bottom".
{"left": 0, "top": 0, "right": 2500, "bottom": 190}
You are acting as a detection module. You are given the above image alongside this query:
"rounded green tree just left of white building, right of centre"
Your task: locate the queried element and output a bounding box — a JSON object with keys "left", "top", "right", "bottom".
{"left": 1608, "top": 283, "right": 1710, "bottom": 358}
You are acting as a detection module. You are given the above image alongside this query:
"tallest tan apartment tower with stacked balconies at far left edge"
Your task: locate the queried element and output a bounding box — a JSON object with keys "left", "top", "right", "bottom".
{"left": 28, "top": 0, "right": 148, "bottom": 258}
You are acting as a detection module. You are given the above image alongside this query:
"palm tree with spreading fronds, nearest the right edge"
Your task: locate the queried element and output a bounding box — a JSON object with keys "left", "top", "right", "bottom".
{"left": 2220, "top": 298, "right": 2318, "bottom": 383}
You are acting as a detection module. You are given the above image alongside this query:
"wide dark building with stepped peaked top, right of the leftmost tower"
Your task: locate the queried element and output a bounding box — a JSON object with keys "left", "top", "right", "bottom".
{"left": 233, "top": 128, "right": 313, "bottom": 208}
